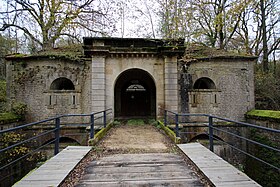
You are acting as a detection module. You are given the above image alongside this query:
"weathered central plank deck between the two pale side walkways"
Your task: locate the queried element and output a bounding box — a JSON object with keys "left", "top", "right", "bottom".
{"left": 77, "top": 153, "right": 204, "bottom": 187}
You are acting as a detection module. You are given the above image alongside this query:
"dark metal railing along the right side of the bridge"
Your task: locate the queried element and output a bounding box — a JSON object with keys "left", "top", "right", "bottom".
{"left": 164, "top": 110, "right": 280, "bottom": 171}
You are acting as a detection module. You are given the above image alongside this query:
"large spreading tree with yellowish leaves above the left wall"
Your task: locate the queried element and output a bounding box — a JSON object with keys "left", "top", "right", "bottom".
{"left": 0, "top": 0, "right": 114, "bottom": 50}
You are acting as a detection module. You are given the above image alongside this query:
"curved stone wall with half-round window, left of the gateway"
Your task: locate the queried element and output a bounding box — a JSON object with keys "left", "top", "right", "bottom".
{"left": 7, "top": 57, "right": 91, "bottom": 122}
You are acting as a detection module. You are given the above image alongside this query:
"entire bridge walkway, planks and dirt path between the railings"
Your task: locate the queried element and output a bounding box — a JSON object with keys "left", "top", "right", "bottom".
{"left": 1, "top": 109, "right": 279, "bottom": 187}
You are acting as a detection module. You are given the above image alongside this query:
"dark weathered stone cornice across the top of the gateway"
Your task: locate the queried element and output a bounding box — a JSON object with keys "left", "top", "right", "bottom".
{"left": 83, "top": 38, "right": 185, "bottom": 57}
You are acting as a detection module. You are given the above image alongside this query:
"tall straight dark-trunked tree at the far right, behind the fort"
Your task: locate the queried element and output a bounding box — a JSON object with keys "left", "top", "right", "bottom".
{"left": 237, "top": 0, "right": 280, "bottom": 72}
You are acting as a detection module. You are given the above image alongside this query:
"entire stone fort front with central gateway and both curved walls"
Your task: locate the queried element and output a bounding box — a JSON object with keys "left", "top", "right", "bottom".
{"left": 6, "top": 37, "right": 255, "bottom": 123}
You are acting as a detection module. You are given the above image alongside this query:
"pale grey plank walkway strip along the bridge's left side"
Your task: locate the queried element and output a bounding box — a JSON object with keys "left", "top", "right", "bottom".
{"left": 14, "top": 146, "right": 91, "bottom": 187}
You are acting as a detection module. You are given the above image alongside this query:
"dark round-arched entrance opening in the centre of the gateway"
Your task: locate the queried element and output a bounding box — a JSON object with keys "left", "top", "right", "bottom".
{"left": 114, "top": 68, "right": 156, "bottom": 117}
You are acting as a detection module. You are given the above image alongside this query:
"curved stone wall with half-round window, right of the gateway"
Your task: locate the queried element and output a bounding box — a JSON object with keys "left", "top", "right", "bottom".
{"left": 185, "top": 57, "right": 254, "bottom": 121}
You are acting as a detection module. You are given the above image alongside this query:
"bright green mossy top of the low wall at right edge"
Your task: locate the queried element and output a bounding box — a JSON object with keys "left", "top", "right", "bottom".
{"left": 246, "top": 110, "right": 280, "bottom": 121}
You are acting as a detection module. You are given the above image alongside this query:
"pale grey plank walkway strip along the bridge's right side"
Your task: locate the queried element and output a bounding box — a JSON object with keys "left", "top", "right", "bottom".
{"left": 178, "top": 143, "right": 260, "bottom": 187}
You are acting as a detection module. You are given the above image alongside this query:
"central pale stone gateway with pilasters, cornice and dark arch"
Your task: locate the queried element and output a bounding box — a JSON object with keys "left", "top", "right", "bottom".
{"left": 84, "top": 38, "right": 185, "bottom": 118}
